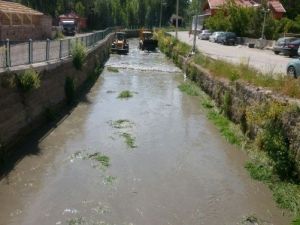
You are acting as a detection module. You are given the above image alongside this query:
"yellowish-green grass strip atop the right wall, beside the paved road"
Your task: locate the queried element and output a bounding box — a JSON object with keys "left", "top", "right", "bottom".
{"left": 156, "top": 31, "right": 300, "bottom": 98}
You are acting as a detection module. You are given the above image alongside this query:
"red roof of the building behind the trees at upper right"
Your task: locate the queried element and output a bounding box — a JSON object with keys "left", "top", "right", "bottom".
{"left": 208, "top": 0, "right": 286, "bottom": 13}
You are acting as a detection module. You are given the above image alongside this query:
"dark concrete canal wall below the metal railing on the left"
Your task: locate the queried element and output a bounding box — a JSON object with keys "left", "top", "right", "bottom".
{"left": 0, "top": 34, "right": 113, "bottom": 159}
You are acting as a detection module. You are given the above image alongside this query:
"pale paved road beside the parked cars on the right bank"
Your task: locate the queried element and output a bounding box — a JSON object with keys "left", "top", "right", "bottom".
{"left": 171, "top": 31, "right": 290, "bottom": 74}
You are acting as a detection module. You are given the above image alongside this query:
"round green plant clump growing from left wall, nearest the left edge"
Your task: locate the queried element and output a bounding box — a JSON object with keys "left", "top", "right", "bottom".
{"left": 17, "top": 68, "right": 41, "bottom": 92}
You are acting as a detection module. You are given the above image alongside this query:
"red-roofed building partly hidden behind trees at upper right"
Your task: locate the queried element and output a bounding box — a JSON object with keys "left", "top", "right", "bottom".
{"left": 203, "top": 0, "right": 286, "bottom": 19}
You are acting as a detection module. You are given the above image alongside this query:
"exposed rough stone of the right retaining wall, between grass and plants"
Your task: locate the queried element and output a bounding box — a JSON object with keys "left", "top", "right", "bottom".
{"left": 178, "top": 56, "right": 300, "bottom": 178}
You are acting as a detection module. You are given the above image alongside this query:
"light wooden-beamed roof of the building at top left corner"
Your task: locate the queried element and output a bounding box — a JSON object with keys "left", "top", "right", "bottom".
{"left": 0, "top": 1, "right": 44, "bottom": 15}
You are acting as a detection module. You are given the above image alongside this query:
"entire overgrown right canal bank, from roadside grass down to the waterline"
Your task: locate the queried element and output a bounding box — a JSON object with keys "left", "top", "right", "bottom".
{"left": 158, "top": 32, "right": 300, "bottom": 221}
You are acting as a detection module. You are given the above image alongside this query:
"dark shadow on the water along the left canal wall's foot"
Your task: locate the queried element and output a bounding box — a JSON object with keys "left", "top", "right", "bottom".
{"left": 0, "top": 68, "right": 100, "bottom": 183}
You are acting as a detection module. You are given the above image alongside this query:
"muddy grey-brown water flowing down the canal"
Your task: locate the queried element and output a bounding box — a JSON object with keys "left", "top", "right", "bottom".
{"left": 0, "top": 40, "right": 289, "bottom": 225}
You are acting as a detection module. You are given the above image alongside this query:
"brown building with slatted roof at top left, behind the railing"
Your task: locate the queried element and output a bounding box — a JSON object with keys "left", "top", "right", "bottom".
{"left": 0, "top": 1, "right": 52, "bottom": 41}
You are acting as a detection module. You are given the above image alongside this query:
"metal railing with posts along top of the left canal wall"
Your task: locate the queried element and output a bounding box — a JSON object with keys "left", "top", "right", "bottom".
{"left": 0, "top": 28, "right": 114, "bottom": 68}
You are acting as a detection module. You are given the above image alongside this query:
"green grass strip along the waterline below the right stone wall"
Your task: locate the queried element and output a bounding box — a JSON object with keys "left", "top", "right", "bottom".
{"left": 179, "top": 78, "right": 300, "bottom": 221}
